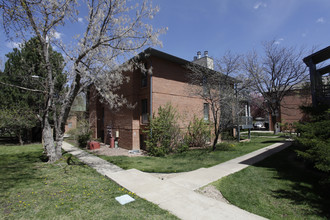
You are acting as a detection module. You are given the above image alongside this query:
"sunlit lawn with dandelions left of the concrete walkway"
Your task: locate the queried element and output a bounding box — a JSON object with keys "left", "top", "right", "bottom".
{"left": 0, "top": 145, "right": 177, "bottom": 219}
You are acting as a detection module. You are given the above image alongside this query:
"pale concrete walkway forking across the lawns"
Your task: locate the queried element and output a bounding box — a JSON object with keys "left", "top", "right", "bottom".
{"left": 63, "top": 142, "right": 291, "bottom": 220}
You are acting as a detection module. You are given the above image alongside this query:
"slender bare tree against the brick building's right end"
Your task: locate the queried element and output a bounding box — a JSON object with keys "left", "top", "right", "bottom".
{"left": 187, "top": 52, "right": 246, "bottom": 150}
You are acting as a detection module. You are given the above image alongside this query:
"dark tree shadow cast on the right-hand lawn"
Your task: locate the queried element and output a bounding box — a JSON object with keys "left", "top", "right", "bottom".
{"left": 254, "top": 146, "right": 330, "bottom": 219}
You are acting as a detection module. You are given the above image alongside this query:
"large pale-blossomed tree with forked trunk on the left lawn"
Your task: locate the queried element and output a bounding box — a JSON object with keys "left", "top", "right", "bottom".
{"left": 0, "top": 0, "right": 163, "bottom": 162}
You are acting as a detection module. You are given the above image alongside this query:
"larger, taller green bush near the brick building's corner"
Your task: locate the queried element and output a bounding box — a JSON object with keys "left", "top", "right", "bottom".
{"left": 145, "top": 103, "right": 181, "bottom": 157}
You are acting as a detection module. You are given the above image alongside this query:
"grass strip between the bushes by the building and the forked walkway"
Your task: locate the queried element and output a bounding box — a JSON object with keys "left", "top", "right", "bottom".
{"left": 100, "top": 138, "right": 283, "bottom": 173}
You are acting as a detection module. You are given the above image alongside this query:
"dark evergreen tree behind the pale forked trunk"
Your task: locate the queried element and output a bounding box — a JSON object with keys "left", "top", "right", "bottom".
{"left": 0, "top": 38, "right": 66, "bottom": 144}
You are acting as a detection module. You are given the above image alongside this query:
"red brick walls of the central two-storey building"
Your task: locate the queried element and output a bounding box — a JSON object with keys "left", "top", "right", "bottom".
{"left": 89, "top": 54, "right": 209, "bottom": 149}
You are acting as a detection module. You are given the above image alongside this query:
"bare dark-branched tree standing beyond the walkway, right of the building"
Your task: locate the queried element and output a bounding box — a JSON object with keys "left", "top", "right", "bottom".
{"left": 243, "top": 41, "right": 307, "bottom": 133}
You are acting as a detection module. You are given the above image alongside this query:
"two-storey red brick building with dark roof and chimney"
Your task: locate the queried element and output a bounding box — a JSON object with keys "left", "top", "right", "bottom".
{"left": 89, "top": 48, "right": 218, "bottom": 149}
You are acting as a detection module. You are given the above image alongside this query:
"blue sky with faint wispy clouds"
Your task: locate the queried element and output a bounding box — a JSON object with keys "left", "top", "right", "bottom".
{"left": 0, "top": 0, "right": 330, "bottom": 65}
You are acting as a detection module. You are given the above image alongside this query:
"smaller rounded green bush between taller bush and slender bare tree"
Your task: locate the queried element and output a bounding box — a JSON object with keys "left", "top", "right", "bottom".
{"left": 185, "top": 116, "right": 211, "bottom": 147}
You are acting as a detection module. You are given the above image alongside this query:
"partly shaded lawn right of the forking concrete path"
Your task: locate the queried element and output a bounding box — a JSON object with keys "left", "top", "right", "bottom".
{"left": 213, "top": 147, "right": 330, "bottom": 219}
